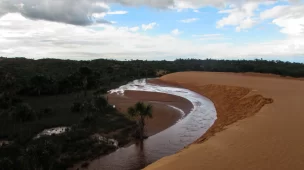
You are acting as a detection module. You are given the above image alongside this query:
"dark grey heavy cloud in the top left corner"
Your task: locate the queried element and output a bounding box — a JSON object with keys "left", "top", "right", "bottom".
{"left": 0, "top": 0, "right": 109, "bottom": 26}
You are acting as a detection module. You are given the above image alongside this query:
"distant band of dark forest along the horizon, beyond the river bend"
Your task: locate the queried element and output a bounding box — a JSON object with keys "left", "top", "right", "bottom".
{"left": 0, "top": 58, "right": 304, "bottom": 95}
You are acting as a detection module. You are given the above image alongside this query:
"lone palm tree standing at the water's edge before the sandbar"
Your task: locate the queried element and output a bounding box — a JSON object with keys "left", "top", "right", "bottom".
{"left": 128, "top": 102, "right": 152, "bottom": 140}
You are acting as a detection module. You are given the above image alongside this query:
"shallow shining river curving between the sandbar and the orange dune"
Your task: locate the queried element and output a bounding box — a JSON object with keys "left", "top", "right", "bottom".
{"left": 77, "top": 79, "right": 216, "bottom": 170}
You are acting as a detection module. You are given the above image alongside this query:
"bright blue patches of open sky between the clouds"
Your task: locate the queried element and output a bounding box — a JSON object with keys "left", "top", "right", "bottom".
{"left": 105, "top": 2, "right": 289, "bottom": 43}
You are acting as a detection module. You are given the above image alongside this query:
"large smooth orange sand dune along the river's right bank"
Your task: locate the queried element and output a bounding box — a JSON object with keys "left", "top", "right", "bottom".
{"left": 146, "top": 72, "right": 304, "bottom": 170}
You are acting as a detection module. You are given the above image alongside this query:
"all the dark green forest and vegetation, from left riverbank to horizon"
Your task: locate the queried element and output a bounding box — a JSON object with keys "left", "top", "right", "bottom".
{"left": 0, "top": 57, "right": 304, "bottom": 170}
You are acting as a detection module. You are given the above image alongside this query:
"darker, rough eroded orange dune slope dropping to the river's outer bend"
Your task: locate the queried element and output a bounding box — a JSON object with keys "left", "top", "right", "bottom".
{"left": 192, "top": 84, "right": 273, "bottom": 143}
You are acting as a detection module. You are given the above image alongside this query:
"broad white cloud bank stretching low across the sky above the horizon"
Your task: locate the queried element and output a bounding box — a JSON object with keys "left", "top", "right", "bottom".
{"left": 0, "top": 14, "right": 304, "bottom": 59}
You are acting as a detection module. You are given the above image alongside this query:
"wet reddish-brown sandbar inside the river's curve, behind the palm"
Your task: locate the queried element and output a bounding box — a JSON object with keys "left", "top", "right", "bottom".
{"left": 108, "top": 91, "right": 193, "bottom": 136}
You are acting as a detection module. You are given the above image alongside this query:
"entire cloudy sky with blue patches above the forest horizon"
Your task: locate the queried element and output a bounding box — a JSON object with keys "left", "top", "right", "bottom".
{"left": 0, "top": 0, "right": 304, "bottom": 62}
